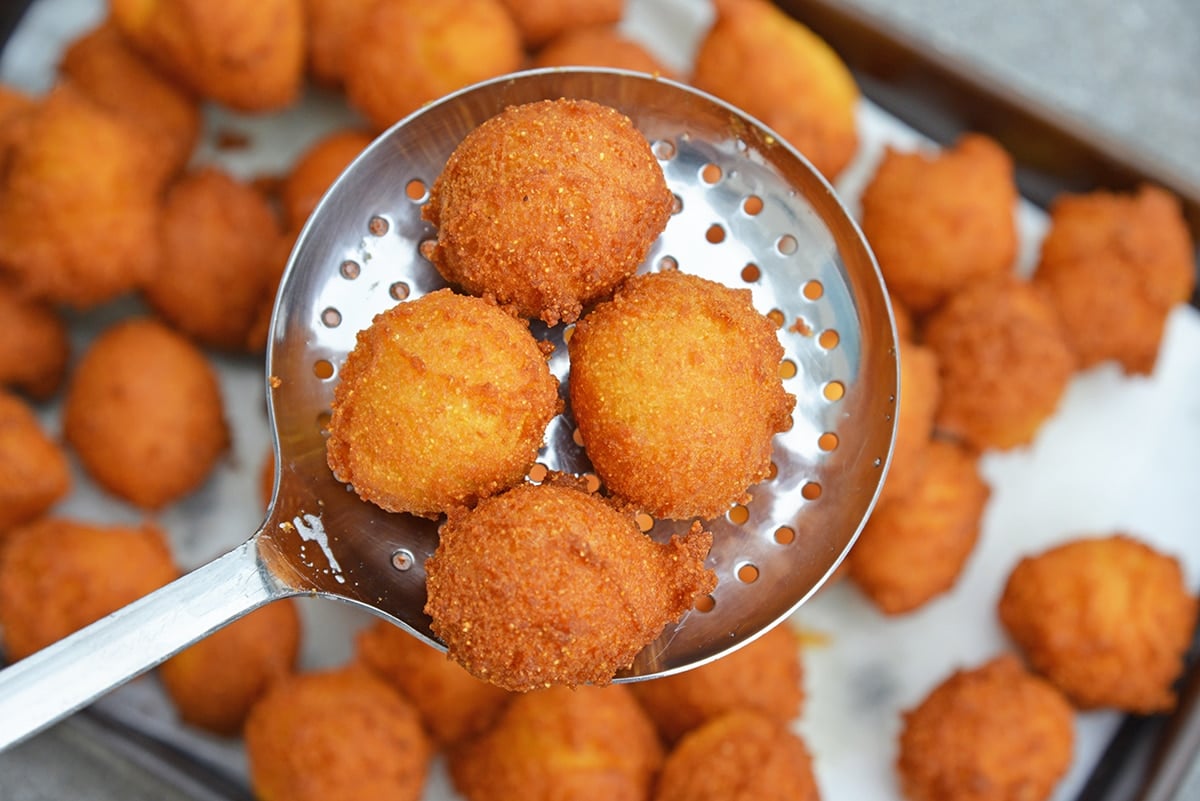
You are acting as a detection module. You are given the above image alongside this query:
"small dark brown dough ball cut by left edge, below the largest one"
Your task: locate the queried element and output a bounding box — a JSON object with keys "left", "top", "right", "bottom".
{"left": 0, "top": 281, "right": 71, "bottom": 401}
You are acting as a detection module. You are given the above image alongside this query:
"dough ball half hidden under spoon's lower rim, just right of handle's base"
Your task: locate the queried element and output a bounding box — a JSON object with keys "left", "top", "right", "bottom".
{"left": 355, "top": 620, "right": 512, "bottom": 746}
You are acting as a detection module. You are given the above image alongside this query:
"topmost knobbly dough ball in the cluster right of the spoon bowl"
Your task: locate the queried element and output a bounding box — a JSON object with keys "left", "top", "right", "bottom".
{"left": 862, "top": 134, "right": 1018, "bottom": 314}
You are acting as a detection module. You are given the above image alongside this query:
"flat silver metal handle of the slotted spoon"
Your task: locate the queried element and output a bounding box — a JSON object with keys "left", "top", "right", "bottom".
{"left": 0, "top": 536, "right": 284, "bottom": 751}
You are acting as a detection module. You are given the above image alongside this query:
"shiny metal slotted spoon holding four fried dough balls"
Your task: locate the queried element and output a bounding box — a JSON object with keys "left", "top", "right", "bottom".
{"left": 0, "top": 70, "right": 899, "bottom": 747}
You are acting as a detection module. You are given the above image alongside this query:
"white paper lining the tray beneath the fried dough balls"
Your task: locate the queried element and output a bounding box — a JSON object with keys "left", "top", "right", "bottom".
{"left": 0, "top": 0, "right": 1200, "bottom": 801}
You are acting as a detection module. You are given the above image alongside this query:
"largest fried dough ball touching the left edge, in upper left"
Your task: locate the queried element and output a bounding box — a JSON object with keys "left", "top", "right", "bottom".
{"left": 0, "top": 85, "right": 162, "bottom": 308}
